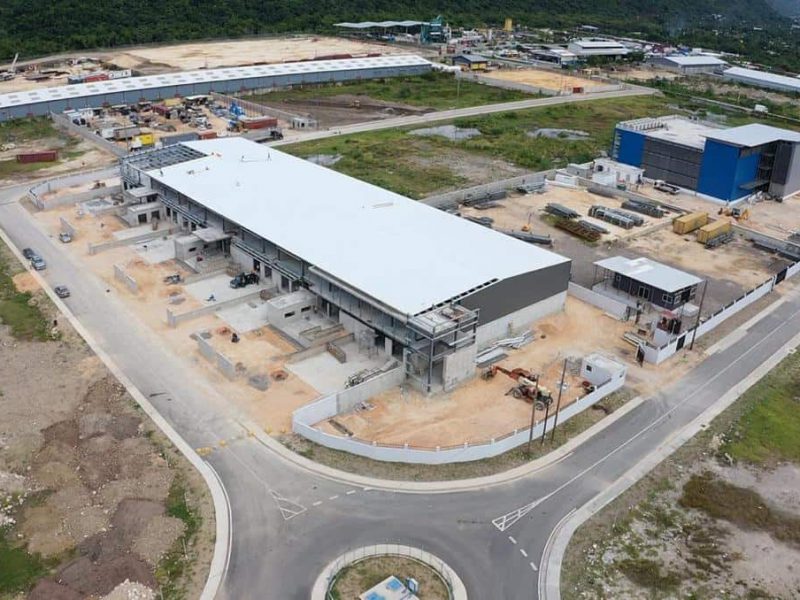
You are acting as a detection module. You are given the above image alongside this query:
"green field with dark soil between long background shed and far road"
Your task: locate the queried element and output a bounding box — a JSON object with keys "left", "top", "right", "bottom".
{"left": 245, "top": 72, "right": 537, "bottom": 110}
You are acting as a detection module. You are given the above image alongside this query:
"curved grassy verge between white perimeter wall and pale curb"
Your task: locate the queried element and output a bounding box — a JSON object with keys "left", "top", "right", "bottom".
{"left": 280, "top": 388, "right": 632, "bottom": 481}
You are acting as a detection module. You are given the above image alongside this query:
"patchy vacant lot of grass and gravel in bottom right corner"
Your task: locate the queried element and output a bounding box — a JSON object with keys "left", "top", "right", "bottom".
{"left": 561, "top": 354, "right": 800, "bottom": 600}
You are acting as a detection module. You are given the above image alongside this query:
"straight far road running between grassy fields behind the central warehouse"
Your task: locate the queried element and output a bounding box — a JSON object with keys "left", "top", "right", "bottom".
{"left": 272, "top": 86, "right": 657, "bottom": 146}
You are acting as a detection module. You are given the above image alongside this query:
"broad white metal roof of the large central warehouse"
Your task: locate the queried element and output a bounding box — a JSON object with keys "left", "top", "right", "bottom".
{"left": 148, "top": 137, "right": 569, "bottom": 315}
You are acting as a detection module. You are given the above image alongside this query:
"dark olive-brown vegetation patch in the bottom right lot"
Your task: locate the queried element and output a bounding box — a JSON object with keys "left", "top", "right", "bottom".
{"left": 679, "top": 472, "right": 800, "bottom": 545}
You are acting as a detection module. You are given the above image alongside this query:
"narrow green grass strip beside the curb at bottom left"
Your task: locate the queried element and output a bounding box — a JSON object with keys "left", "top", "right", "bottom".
{"left": 156, "top": 477, "right": 201, "bottom": 600}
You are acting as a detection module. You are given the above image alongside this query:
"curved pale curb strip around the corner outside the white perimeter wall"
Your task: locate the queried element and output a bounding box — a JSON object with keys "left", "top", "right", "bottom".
{"left": 240, "top": 396, "right": 647, "bottom": 494}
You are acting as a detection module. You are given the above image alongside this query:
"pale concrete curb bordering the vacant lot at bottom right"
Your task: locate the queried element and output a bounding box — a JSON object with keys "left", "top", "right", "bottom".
{"left": 539, "top": 316, "right": 800, "bottom": 600}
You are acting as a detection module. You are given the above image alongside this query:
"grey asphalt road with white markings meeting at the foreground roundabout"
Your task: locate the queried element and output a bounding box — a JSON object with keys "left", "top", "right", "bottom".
{"left": 0, "top": 189, "right": 800, "bottom": 600}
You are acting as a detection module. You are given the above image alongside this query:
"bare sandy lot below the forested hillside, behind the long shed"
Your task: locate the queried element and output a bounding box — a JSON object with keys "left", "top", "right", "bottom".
{"left": 104, "top": 36, "right": 408, "bottom": 74}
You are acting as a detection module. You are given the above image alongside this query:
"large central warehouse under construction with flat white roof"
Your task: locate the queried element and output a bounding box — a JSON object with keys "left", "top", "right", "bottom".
{"left": 121, "top": 137, "right": 570, "bottom": 391}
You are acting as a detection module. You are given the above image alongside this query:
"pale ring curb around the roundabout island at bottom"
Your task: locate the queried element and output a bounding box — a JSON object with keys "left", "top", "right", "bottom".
{"left": 310, "top": 544, "right": 467, "bottom": 600}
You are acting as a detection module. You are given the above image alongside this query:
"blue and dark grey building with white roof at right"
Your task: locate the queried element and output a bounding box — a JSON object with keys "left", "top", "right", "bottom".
{"left": 611, "top": 116, "right": 800, "bottom": 202}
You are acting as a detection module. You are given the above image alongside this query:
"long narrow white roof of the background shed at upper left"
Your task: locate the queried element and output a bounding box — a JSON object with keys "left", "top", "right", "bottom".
{"left": 0, "top": 54, "right": 430, "bottom": 108}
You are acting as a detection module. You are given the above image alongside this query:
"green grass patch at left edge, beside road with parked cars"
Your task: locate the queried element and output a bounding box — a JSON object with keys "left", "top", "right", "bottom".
{"left": 0, "top": 247, "right": 52, "bottom": 341}
